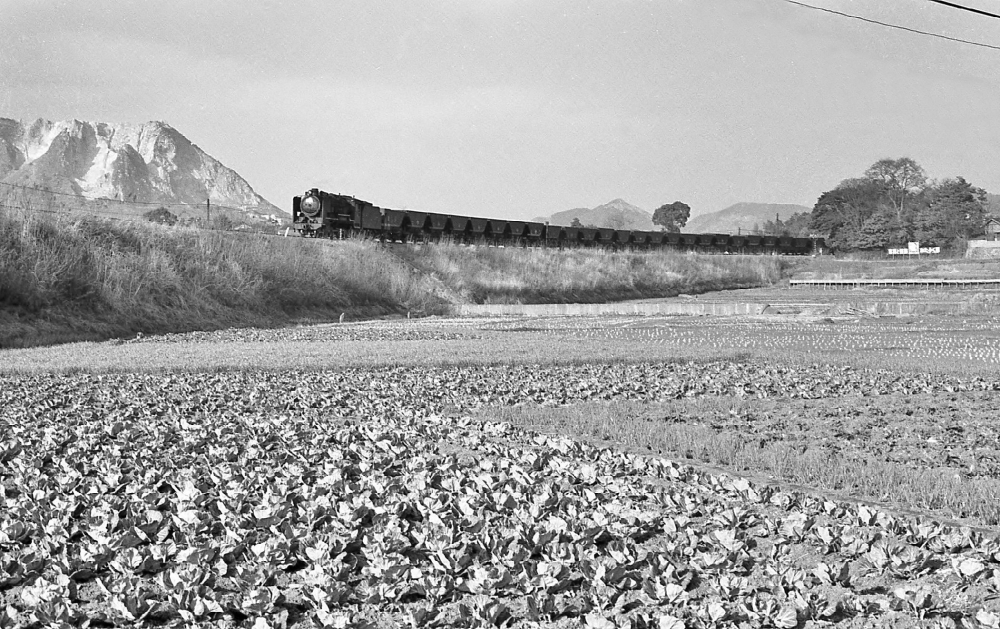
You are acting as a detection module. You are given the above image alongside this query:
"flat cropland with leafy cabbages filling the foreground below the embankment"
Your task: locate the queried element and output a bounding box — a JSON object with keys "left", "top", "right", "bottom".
{"left": 0, "top": 319, "right": 1000, "bottom": 629}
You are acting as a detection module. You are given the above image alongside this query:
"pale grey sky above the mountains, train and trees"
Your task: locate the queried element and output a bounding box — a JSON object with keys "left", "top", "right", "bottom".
{"left": 0, "top": 0, "right": 1000, "bottom": 219}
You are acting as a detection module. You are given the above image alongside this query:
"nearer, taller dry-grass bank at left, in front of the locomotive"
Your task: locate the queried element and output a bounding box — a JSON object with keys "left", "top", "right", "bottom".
{"left": 0, "top": 212, "right": 447, "bottom": 347}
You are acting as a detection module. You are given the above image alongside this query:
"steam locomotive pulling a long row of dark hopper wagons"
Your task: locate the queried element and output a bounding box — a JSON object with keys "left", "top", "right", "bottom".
{"left": 292, "top": 188, "right": 825, "bottom": 255}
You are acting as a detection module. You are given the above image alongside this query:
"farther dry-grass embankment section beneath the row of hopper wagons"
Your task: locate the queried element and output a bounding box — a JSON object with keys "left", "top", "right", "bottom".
{"left": 398, "top": 246, "right": 788, "bottom": 303}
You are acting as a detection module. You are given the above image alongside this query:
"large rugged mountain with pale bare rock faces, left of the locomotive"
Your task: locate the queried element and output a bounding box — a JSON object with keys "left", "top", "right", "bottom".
{"left": 0, "top": 118, "right": 287, "bottom": 220}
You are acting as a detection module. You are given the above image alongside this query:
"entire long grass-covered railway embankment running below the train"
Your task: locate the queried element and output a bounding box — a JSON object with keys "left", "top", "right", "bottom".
{"left": 0, "top": 211, "right": 787, "bottom": 347}
